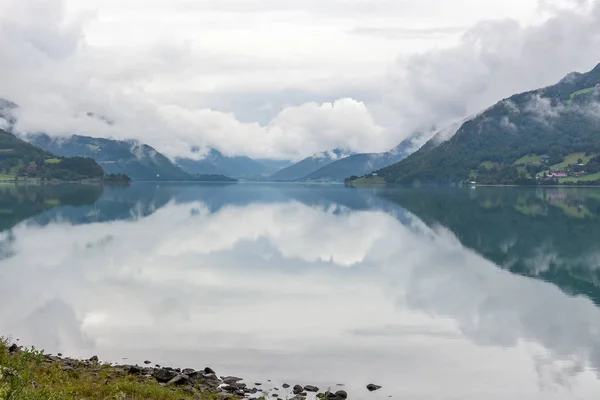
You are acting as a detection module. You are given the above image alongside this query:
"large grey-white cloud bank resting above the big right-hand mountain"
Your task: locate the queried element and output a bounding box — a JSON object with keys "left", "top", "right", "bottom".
{"left": 385, "top": 1, "right": 600, "bottom": 136}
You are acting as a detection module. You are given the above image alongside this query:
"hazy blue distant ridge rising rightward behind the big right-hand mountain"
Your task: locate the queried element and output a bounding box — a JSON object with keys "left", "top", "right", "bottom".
{"left": 301, "top": 135, "right": 421, "bottom": 181}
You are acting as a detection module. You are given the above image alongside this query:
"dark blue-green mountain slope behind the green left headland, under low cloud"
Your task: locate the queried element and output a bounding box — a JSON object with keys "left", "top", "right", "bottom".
{"left": 27, "top": 135, "right": 234, "bottom": 181}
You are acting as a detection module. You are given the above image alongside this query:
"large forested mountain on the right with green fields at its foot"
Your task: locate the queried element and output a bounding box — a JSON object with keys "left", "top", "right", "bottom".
{"left": 377, "top": 64, "right": 600, "bottom": 184}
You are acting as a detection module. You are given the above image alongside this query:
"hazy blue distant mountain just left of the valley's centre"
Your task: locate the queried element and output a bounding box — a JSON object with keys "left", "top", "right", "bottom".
{"left": 175, "top": 148, "right": 273, "bottom": 179}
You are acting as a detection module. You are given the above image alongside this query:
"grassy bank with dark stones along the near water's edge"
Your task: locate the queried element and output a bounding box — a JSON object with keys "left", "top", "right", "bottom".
{"left": 0, "top": 337, "right": 380, "bottom": 400}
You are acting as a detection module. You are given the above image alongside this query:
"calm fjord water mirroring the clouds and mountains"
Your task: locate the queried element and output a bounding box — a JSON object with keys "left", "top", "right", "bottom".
{"left": 0, "top": 183, "right": 600, "bottom": 399}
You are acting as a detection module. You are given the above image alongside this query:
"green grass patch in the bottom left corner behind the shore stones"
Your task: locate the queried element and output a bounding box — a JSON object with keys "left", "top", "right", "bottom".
{"left": 0, "top": 338, "right": 219, "bottom": 400}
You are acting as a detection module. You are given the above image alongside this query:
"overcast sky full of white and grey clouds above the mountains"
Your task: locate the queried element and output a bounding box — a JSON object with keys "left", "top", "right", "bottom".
{"left": 0, "top": 0, "right": 600, "bottom": 160}
